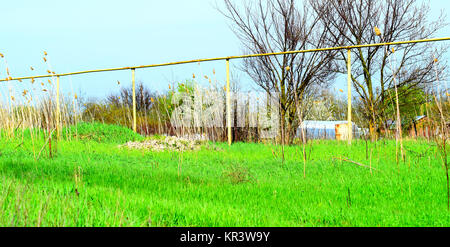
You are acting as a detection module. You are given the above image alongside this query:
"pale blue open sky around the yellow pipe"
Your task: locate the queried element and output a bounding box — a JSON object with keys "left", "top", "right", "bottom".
{"left": 0, "top": 0, "right": 450, "bottom": 100}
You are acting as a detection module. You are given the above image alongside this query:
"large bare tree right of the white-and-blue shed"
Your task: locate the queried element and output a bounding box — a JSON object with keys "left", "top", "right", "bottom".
{"left": 309, "top": 0, "right": 446, "bottom": 139}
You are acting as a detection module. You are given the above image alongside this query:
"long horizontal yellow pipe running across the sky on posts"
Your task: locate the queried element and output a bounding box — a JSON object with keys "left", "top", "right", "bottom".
{"left": 0, "top": 37, "right": 450, "bottom": 82}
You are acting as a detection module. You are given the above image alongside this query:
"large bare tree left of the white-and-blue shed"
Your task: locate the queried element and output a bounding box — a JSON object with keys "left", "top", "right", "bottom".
{"left": 219, "top": 0, "right": 336, "bottom": 143}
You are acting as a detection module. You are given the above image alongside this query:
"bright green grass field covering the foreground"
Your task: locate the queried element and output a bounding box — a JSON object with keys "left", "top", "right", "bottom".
{"left": 0, "top": 124, "right": 450, "bottom": 226}
